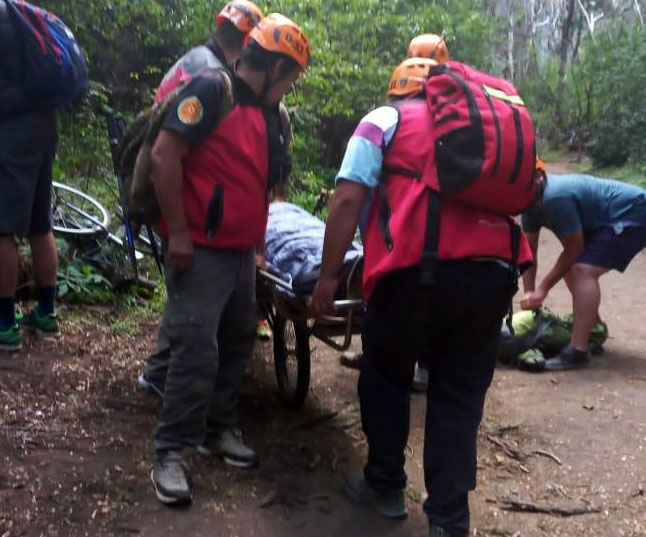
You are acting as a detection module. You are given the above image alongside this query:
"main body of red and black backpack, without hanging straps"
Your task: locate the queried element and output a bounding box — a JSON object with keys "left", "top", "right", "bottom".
{"left": 422, "top": 62, "right": 536, "bottom": 215}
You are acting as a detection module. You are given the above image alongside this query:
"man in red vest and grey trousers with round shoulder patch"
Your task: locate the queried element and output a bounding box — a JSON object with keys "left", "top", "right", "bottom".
{"left": 151, "top": 14, "right": 310, "bottom": 504}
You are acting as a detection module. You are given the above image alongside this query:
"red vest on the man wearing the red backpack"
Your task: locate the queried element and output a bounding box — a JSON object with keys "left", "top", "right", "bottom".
{"left": 363, "top": 100, "right": 532, "bottom": 299}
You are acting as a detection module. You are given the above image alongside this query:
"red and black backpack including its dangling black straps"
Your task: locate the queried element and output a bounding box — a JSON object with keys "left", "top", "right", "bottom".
{"left": 379, "top": 62, "right": 537, "bottom": 326}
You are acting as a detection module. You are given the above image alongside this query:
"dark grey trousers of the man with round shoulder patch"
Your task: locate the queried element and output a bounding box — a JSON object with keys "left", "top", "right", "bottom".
{"left": 155, "top": 248, "right": 256, "bottom": 451}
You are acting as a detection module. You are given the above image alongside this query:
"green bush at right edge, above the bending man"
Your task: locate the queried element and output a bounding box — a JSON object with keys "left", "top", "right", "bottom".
{"left": 522, "top": 25, "right": 646, "bottom": 167}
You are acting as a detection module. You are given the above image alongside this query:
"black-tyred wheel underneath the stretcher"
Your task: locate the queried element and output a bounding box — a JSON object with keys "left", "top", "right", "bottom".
{"left": 274, "top": 314, "right": 310, "bottom": 408}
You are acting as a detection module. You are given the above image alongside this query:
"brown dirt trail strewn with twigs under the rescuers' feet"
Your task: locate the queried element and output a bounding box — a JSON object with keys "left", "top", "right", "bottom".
{"left": 0, "top": 162, "right": 646, "bottom": 537}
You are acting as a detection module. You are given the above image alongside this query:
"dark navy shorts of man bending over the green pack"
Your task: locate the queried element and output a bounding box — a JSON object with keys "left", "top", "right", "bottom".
{"left": 578, "top": 226, "right": 646, "bottom": 272}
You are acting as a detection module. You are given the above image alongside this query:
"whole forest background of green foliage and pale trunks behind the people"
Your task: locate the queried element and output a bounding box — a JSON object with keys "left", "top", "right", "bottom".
{"left": 41, "top": 0, "right": 646, "bottom": 208}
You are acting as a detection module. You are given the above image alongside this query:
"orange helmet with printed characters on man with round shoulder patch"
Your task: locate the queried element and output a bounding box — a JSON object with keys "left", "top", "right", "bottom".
{"left": 249, "top": 13, "right": 310, "bottom": 73}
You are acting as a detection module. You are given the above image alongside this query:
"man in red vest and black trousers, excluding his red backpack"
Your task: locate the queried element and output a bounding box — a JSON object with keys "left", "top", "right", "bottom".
{"left": 310, "top": 58, "right": 531, "bottom": 537}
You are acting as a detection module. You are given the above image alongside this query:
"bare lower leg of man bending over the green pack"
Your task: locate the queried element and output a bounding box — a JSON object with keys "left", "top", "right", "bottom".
{"left": 565, "top": 263, "right": 608, "bottom": 351}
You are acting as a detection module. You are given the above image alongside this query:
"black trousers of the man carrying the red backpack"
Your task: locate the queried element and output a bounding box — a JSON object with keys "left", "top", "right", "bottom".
{"left": 359, "top": 261, "right": 515, "bottom": 536}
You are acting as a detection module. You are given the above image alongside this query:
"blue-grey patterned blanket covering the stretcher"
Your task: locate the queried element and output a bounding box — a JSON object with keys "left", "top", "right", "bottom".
{"left": 265, "top": 201, "right": 363, "bottom": 294}
